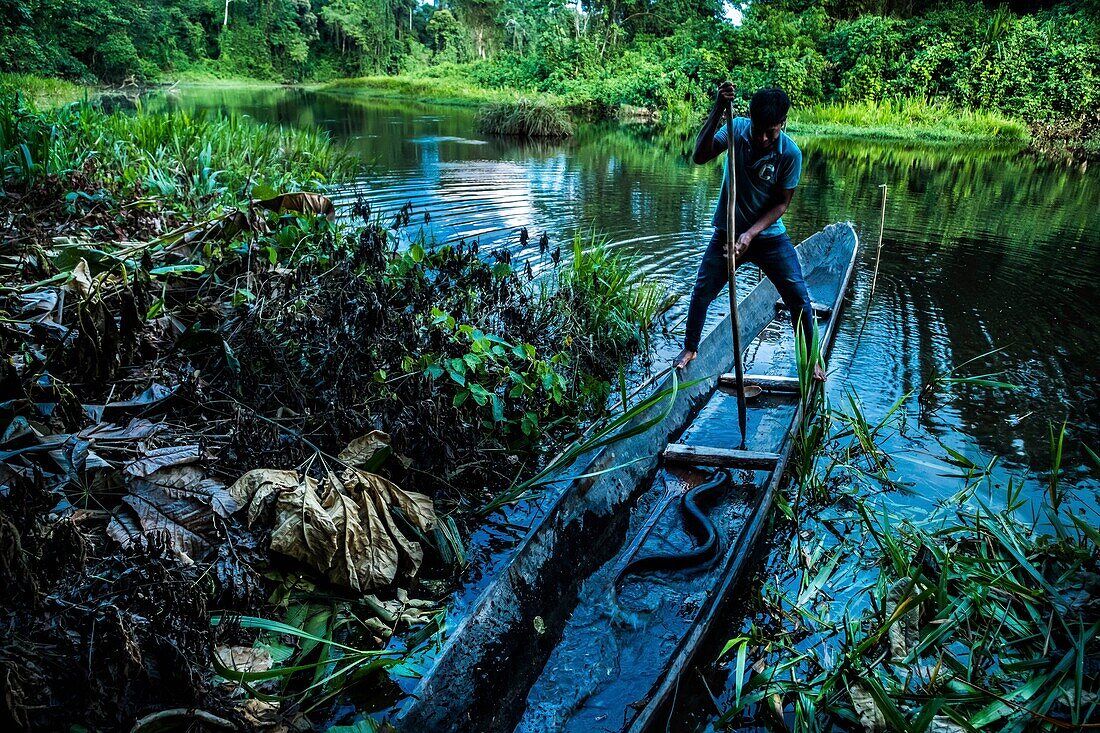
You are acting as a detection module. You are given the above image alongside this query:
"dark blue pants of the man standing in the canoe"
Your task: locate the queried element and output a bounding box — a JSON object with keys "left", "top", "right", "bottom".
{"left": 684, "top": 229, "right": 814, "bottom": 351}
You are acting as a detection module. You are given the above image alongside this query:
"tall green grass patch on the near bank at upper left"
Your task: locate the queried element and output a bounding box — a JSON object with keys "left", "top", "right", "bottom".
{"left": 0, "top": 95, "right": 355, "bottom": 214}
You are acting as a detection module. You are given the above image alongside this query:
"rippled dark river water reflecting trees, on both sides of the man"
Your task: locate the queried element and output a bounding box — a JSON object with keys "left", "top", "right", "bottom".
{"left": 158, "top": 84, "right": 1100, "bottom": 724}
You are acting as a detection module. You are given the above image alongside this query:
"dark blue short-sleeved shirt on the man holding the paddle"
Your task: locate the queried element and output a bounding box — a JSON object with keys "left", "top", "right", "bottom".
{"left": 711, "top": 117, "right": 802, "bottom": 237}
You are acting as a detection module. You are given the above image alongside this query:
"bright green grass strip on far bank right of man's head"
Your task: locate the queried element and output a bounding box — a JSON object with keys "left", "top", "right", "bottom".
{"left": 791, "top": 98, "right": 1030, "bottom": 143}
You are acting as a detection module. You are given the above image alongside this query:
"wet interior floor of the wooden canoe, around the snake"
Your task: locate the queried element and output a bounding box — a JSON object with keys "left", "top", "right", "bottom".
{"left": 515, "top": 224, "right": 856, "bottom": 733}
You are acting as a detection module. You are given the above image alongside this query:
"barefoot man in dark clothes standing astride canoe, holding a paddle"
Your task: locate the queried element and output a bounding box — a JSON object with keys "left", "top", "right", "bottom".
{"left": 675, "top": 81, "right": 825, "bottom": 381}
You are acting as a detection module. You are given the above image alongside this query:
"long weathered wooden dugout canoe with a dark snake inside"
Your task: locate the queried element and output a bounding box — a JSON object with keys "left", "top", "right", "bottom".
{"left": 394, "top": 223, "right": 858, "bottom": 733}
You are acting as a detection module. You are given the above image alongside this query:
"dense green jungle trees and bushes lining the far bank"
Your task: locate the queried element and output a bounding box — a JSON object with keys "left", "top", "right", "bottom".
{"left": 0, "top": 0, "right": 1100, "bottom": 124}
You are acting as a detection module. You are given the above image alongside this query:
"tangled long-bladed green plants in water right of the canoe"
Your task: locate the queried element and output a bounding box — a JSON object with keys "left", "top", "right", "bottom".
{"left": 718, "top": 385, "right": 1100, "bottom": 731}
